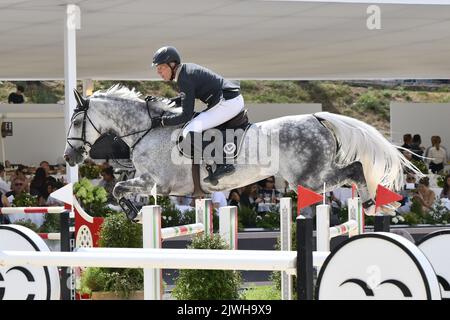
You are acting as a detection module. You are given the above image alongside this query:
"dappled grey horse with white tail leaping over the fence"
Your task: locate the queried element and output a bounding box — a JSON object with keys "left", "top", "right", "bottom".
{"left": 64, "top": 86, "right": 417, "bottom": 214}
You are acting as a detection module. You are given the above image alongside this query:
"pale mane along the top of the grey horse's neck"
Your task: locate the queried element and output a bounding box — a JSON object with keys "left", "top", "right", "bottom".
{"left": 90, "top": 84, "right": 181, "bottom": 113}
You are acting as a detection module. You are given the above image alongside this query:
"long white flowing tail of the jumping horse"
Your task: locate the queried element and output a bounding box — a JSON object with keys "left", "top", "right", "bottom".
{"left": 314, "top": 112, "right": 422, "bottom": 197}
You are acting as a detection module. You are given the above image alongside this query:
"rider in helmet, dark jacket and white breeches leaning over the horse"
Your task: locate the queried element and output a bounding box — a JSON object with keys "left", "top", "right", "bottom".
{"left": 152, "top": 46, "right": 244, "bottom": 182}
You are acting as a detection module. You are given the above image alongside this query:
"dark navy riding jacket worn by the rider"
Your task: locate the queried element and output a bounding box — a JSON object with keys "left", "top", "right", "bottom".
{"left": 162, "top": 63, "right": 240, "bottom": 126}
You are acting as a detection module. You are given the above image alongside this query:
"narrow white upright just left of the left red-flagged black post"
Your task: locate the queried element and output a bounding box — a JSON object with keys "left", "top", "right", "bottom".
{"left": 280, "top": 198, "right": 294, "bottom": 300}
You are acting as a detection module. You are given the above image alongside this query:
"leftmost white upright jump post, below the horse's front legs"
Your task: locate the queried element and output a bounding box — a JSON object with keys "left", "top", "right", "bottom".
{"left": 141, "top": 206, "right": 162, "bottom": 300}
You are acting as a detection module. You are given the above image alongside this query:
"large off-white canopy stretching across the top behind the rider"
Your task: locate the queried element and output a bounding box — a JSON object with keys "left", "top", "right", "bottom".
{"left": 0, "top": 0, "right": 450, "bottom": 80}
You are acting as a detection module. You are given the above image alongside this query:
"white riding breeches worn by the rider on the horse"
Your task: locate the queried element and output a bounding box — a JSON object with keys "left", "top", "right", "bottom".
{"left": 183, "top": 95, "right": 244, "bottom": 138}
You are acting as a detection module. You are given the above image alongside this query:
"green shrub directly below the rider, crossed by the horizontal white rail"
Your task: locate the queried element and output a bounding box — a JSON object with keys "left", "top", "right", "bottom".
{"left": 172, "top": 235, "right": 242, "bottom": 300}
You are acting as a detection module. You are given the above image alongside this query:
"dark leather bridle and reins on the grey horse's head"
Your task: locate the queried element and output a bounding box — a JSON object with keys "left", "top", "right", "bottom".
{"left": 67, "top": 90, "right": 160, "bottom": 160}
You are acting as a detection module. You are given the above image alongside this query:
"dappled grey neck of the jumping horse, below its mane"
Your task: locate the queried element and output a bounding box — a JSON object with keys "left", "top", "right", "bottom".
{"left": 95, "top": 103, "right": 151, "bottom": 147}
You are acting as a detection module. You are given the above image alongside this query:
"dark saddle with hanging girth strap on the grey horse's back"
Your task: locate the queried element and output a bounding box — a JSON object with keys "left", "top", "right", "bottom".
{"left": 177, "top": 110, "right": 251, "bottom": 197}
